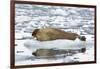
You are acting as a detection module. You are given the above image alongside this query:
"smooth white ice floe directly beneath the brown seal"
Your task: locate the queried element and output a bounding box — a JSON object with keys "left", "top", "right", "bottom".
{"left": 24, "top": 39, "right": 85, "bottom": 50}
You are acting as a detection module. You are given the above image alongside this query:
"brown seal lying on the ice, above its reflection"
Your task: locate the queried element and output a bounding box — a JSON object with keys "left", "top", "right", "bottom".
{"left": 32, "top": 28, "right": 86, "bottom": 41}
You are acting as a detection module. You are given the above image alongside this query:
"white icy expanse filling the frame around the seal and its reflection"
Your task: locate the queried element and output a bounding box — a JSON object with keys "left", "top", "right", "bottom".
{"left": 15, "top": 4, "right": 94, "bottom": 65}
